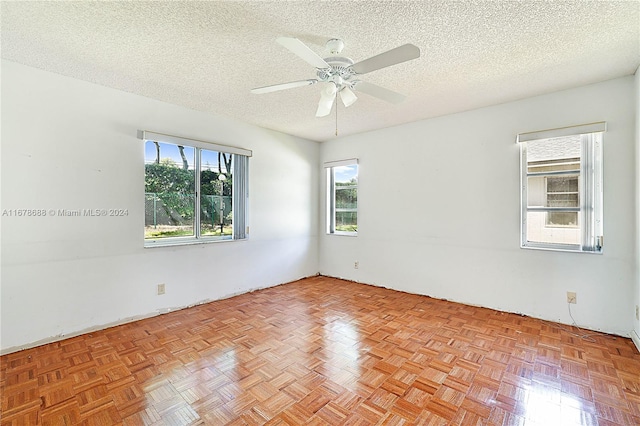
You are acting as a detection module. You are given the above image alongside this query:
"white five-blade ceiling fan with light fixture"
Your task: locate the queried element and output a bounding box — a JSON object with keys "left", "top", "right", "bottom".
{"left": 251, "top": 37, "right": 420, "bottom": 117}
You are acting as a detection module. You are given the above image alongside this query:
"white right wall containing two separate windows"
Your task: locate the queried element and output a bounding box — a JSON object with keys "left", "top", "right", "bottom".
{"left": 320, "top": 77, "right": 637, "bottom": 335}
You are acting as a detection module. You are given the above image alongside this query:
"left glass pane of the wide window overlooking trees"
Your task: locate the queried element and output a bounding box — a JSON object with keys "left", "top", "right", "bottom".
{"left": 145, "top": 141, "right": 195, "bottom": 239}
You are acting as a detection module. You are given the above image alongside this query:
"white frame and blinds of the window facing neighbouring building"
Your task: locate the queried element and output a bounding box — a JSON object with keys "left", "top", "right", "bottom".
{"left": 516, "top": 122, "right": 606, "bottom": 253}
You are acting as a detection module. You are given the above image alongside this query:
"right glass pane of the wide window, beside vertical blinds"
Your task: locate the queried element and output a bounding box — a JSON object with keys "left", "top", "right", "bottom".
{"left": 200, "top": 149, "right": 233, "bottom": 238}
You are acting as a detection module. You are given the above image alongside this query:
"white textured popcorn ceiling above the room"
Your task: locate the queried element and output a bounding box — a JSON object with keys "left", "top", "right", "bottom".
{"left": 1, "top": 0, "right": 640, "bottom": 141}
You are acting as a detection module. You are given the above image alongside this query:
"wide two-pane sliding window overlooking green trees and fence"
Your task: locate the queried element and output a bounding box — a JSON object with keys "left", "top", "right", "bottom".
{"left": 138, "top": 131, "right": 251, "bottom": 246}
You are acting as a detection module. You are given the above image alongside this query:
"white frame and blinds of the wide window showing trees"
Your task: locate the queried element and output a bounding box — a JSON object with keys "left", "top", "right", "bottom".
{"left": 137, "top": 130, "right": 252, "bottom": 247}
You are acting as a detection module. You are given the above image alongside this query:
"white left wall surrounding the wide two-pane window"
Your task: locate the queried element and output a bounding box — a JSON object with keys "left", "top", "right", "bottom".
{"left": 0, "top": 61, "right": 319, "bottom": 352}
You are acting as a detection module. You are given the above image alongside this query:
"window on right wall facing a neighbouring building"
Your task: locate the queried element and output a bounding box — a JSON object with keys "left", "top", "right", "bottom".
{"left": 518, "top": 123, "right": 605, "bottom": 252}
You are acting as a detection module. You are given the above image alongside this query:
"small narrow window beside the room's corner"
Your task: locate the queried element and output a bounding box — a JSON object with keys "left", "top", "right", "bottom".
{"left": 325, "top": 159, "right": 358, "bottom": 235}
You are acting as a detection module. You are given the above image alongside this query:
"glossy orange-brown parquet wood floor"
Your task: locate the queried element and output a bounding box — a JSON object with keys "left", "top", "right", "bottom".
{"left": 0, "top": 277, "right": 640, "bottom": 426}
